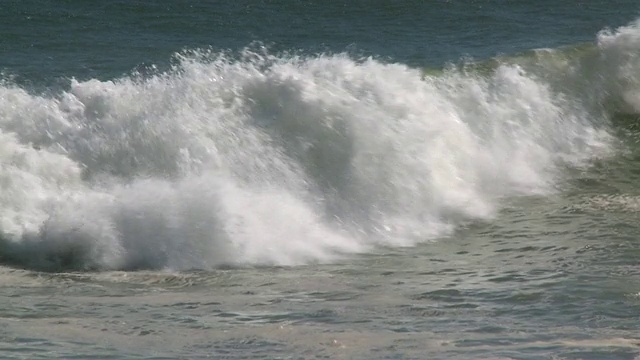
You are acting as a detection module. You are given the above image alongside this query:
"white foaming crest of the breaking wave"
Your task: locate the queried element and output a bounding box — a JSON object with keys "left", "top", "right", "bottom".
{"left": 5, "top": 19, "right": 640, "bottom": 271}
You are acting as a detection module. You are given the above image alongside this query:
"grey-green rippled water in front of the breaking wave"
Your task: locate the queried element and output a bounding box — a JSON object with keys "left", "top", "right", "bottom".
{"left": 1, "top": 198, "right": 640, "bottom": 359}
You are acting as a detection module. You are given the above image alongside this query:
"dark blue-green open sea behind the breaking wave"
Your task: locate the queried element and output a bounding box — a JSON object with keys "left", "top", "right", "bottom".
{"left": 0, "top": 0, "right": 640, "bottom": 83}
